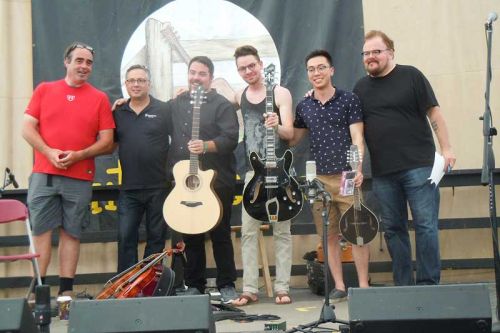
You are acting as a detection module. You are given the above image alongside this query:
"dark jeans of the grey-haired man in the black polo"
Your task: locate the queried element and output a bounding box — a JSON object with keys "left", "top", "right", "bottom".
{"left": 118, "top": 188, "right": 169, "bottom": 272}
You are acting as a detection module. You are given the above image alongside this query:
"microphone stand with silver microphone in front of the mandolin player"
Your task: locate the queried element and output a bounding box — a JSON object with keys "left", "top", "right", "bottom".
{"left": 286, "top": 185, "right": 349, "bottom": 333}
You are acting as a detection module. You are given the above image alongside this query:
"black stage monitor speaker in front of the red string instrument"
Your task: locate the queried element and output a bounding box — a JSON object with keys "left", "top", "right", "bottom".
{"left": 68, "top": 295, "right": 215, "bottom": 333}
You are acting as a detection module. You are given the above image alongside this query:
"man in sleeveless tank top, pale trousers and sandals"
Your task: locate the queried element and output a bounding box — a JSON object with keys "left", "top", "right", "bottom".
{"left": 232, "top": 45, "right": 293, "bottom": 306}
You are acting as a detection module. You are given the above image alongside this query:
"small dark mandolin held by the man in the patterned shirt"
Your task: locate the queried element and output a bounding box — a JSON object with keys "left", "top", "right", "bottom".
{"left": 340, "top": 145, "right": 378, "bottom": 245}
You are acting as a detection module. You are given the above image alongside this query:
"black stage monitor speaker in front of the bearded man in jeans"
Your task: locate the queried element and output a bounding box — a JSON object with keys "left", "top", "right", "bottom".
{"left": 348, "top": 284, "right": 491, "bottom": 333}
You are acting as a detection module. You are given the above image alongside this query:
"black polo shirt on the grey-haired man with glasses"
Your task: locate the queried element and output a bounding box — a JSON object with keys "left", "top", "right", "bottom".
{"left": 113, "top": 96, "right": 171, "bottom": 190}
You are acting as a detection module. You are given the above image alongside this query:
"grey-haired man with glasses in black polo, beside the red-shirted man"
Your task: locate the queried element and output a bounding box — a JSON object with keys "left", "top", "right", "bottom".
{"left": 114, "top": 65, "right": 170, "bottom": 272}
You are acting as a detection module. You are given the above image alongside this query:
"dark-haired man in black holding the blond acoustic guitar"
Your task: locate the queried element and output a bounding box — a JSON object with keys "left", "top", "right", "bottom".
{"left": 168, "top": 56, "right": 239, "bottom": 303}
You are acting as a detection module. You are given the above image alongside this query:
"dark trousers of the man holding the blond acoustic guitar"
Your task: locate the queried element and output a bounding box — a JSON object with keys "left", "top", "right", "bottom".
{"left": 183, "top": 187, "right": 236, "bottom": 293}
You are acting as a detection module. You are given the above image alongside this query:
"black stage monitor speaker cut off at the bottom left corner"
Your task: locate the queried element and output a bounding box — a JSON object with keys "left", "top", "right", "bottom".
{"left": 0, "top": 298, "right": 38, "bottom": 333}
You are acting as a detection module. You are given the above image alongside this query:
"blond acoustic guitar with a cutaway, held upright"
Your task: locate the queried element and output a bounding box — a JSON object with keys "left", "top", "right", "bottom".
{"left": 163, "top": 86, "right": 222, "bottom": 234}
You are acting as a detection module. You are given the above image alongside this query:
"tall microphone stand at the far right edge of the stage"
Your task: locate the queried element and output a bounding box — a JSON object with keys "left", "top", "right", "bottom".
{"left": 479, "top": 17, "right": 500, "bottom": 318}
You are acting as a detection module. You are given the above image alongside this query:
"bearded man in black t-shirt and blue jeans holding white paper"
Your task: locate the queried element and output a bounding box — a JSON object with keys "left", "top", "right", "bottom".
{"left": 354, "top": 31, "right": 456, "bottom": 285}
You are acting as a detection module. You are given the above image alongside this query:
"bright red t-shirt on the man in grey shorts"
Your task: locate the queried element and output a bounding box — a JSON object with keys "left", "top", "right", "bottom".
{"left": 25, "top": 80, "right": 115, "bottom": 180}
